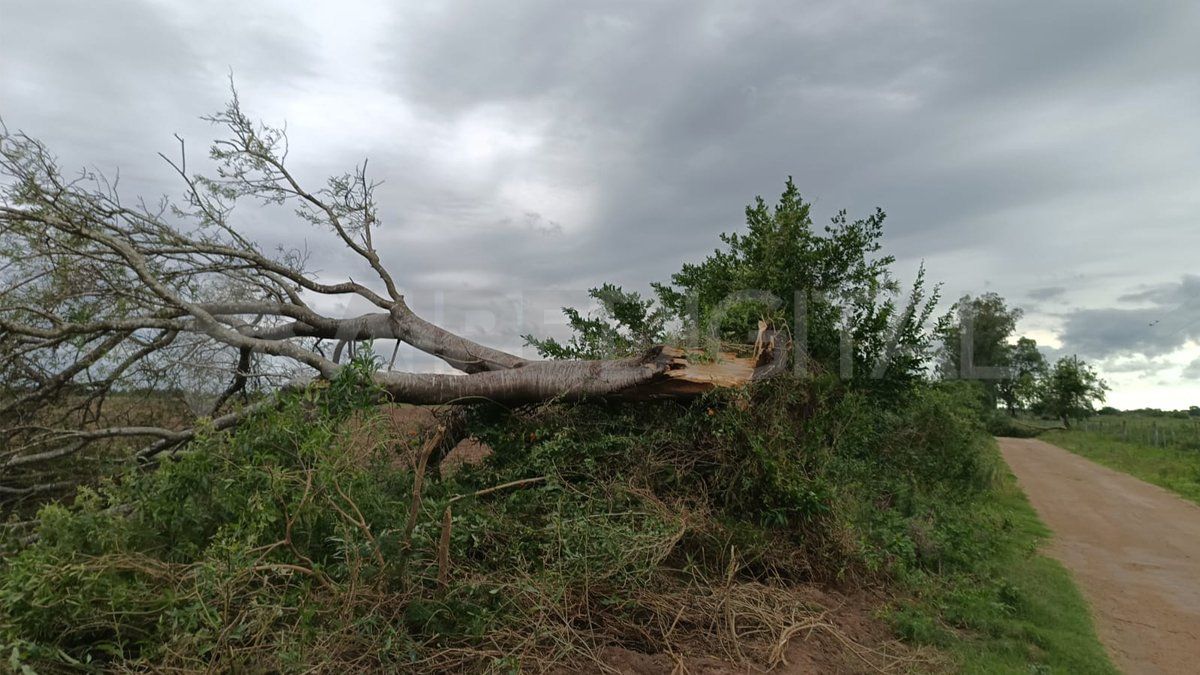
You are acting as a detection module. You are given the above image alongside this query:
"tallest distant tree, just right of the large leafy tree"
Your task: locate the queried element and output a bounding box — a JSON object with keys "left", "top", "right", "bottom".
{"left": 937, "top": 293, "right": 1024, "bottom": 408}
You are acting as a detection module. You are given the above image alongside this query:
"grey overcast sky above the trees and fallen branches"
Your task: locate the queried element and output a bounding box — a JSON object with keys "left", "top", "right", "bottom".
{"left": 0, "top": 0, "right": 1200, "bottom": 407}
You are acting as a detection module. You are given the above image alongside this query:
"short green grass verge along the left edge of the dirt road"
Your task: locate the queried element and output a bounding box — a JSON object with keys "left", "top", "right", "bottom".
{"left": 890, "top": 446, "right": 1117, "bottom": 674}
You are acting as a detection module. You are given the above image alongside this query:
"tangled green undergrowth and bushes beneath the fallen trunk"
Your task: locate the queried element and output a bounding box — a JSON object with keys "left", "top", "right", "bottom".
{"left": 0, "top": 353, "right": 1032, "bottom": 671}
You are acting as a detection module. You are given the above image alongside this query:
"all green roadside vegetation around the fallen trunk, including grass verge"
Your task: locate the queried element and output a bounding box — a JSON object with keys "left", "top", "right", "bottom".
{"left": 0, "top": 178, "right": 1109, "bottom": 671}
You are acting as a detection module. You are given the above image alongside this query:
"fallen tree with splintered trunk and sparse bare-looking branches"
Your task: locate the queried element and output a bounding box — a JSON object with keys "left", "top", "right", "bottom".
{"left": 0, "top": 95, "right": 787, "bottom": 482}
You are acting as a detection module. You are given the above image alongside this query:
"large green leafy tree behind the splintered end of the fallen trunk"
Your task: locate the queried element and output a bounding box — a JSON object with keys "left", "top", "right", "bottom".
{"left": 526, "top": 179, "right": 940, "bottom": 394}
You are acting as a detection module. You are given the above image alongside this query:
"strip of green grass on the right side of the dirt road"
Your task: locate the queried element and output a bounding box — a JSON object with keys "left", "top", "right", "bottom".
{"left": 1042, "top": 429, "right": 1200, "bottom": 503}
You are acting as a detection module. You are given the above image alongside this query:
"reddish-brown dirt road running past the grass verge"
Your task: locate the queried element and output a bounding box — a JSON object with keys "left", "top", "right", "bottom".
{"left": 1000, "top": 438, "right": 1200, "bottom": 674}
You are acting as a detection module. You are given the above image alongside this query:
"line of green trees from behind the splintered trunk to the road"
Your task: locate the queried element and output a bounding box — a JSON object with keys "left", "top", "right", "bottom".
{"left": 524, "top": 187, "right": 1108, "bottom": 425}
